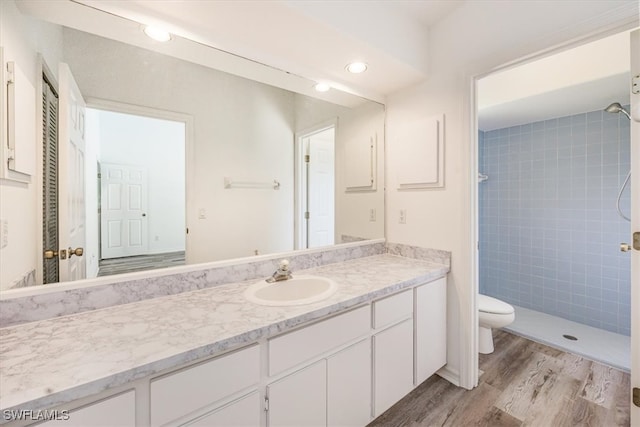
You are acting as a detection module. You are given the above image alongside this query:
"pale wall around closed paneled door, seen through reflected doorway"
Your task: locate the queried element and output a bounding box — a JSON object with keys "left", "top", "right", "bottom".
{"left": 97, "top": 110, "right": 186, "bottom": 254}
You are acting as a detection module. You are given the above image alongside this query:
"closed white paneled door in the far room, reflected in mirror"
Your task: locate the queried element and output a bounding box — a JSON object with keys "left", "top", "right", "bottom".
{"left": 100, "top": 163, "right": 149, "bottom": 259}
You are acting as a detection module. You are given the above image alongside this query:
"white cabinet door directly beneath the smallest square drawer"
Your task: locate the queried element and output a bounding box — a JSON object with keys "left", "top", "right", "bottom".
{"left": 373, "top": 319, "right": 413, "bottom": 417}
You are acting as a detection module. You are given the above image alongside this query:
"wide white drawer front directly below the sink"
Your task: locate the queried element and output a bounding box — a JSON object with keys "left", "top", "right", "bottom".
{"left": 269, "top": 306, "right": 371, "bottom": 376}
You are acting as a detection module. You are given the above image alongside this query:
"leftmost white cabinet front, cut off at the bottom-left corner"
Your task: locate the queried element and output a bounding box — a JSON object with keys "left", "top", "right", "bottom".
{"left": 39, "top": 390, "right": 136, "bottom": 427}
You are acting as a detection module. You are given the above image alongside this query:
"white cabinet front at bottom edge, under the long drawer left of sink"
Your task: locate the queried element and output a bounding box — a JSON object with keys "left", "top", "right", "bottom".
{"left": 185, "top": 391, "right": 262, "bottom": 427}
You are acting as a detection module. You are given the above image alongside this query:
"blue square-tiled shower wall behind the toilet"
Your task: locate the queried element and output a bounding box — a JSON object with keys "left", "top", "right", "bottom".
{"left": 478, "top": 105, "right": 631, "bottom": 336}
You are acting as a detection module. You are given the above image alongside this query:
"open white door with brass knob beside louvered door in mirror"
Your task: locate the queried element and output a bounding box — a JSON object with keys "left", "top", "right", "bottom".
{"left": 58, "top": 64, "right": 86, "bottom": 282}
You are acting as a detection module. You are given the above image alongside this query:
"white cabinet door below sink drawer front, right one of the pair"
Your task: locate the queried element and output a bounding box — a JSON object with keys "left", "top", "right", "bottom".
{"left": 327, "top": 339, "right": 371, "bottom": 427}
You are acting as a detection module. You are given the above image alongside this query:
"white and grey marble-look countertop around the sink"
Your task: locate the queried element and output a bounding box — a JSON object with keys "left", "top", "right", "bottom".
{"left": 0, "top": 254, "right": 449, "bottom": 410}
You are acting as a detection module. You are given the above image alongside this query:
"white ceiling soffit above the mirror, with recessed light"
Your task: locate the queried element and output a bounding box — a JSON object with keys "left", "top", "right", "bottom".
{"left": 72, "top": 0, "right": 462, "bottom": 101}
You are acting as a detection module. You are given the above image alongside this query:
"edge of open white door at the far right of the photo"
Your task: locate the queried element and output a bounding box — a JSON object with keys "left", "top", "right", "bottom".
{"left": 630, "top": 30, "right": 640, "bottom": 426}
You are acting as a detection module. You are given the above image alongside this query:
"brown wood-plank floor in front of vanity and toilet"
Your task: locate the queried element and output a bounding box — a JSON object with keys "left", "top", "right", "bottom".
{"left": 369, "top": 331, "right": 630, "bottom": 427}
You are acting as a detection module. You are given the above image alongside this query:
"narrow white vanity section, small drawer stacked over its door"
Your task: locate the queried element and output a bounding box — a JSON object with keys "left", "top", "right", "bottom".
{"left": 373, "top": 289, "right": 414, "bottom": 417}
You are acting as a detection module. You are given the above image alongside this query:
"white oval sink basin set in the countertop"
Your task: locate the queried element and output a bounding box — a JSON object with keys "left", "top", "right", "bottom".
{"left": 244, "top": 276, "right": 338, "bottom": 306}
